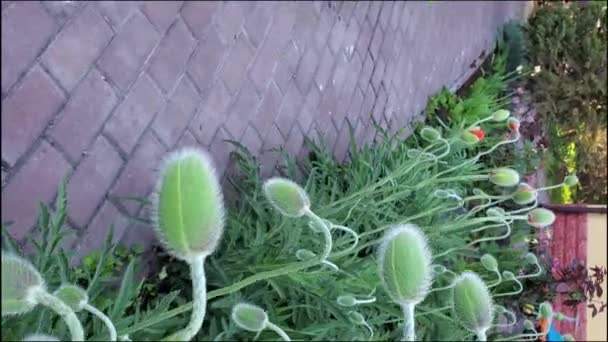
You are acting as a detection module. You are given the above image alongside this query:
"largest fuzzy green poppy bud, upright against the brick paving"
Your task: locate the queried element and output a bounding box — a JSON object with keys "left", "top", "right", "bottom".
{"left": 154, "top": 148, "right": 224, "bottom": 262}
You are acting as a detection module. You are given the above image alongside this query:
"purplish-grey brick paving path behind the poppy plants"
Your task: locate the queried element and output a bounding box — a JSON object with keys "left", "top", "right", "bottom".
{"left": 1, "top": 1, "right": 525, "bottom": 254}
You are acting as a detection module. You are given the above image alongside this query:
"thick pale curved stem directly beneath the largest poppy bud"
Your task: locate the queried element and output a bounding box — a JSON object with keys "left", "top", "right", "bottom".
{"left": 164, "top": 256, "right": 207, "bottom": 341}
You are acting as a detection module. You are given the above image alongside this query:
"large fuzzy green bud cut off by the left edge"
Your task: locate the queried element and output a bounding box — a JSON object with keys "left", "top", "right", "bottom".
{"left": 2, "top": 252, "right": 46, "bottom": 317}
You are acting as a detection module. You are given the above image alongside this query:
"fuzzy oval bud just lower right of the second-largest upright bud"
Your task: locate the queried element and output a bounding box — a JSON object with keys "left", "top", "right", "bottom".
{"left": 452, "top": 272, "right": 494, "bottom": 333}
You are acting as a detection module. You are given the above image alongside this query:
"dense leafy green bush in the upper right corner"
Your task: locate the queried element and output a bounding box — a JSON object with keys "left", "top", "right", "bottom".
{"left": 525, "top": 1, "right": 608, "bottom": 203}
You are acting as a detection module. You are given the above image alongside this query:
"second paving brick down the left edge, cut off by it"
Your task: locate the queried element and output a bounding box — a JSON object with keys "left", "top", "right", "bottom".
{"left": 2, "top": 66, "right": 64, "bottom": 165}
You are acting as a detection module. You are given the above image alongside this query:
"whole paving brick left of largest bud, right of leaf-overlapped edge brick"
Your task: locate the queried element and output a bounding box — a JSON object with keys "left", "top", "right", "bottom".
{"left": 67, "top": 136, "right": 122, "bottom": 227}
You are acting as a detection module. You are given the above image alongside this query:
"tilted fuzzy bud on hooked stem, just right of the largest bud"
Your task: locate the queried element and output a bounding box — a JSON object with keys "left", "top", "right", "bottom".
{"left": 264, "top": 177, "right": 310, "bottom": 217}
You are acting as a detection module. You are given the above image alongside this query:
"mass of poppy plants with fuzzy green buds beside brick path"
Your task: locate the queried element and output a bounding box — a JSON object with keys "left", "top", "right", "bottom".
{"left": 2, "top": 101, "right": 578, "bottom": 341}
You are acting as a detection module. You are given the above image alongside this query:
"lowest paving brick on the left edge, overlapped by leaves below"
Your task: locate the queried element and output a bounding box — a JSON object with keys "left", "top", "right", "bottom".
{"left": 2, "top": 141, "right": 71, "bottom": 240}
